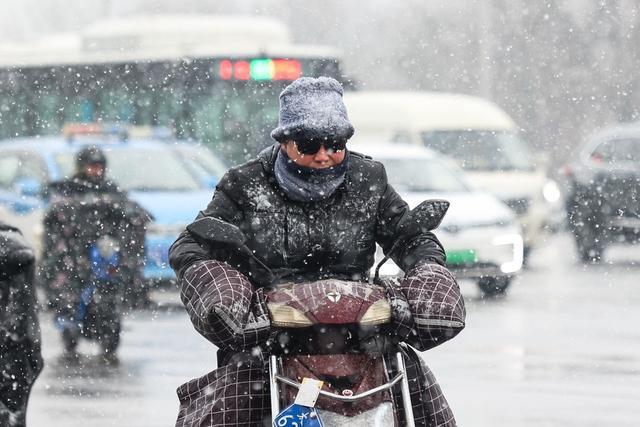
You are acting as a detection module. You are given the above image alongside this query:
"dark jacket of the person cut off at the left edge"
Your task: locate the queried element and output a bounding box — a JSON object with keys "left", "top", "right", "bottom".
{"left": 0, "top": 221, "right": 42, "bottom": 427}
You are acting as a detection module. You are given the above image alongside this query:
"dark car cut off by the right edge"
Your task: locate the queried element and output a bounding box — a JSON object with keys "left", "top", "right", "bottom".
{"left": 563, "top": 123, "right": 640, "bottom": 263}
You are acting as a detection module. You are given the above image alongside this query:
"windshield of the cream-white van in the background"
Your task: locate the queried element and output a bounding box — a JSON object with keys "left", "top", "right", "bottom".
{"left": 422, "top": 130, "right": 534, "bottom": 171}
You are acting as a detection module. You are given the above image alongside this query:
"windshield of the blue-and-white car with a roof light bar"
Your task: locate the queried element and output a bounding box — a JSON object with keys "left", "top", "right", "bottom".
{"left": 57, "top": 149, "right": 200, "bottom": 191}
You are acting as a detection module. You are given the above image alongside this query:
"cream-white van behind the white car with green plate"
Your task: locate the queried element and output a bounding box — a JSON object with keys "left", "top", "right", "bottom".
{"left": 344, "top": 91, "right": 560, "bottom": 256}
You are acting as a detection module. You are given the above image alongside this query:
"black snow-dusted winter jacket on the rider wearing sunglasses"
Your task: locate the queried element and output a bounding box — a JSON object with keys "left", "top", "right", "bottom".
{"left": 169, "top": 144, "right": 444, "bottom": 285}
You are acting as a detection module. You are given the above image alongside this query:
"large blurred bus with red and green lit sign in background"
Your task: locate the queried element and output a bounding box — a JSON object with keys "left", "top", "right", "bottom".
{"left": 0, "top": 15, "right": 348, "bottom": 160}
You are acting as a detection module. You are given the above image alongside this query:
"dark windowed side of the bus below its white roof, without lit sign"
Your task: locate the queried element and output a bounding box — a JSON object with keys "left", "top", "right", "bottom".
{"left": 0, "top": 59, "right": 339, "bottom": 159}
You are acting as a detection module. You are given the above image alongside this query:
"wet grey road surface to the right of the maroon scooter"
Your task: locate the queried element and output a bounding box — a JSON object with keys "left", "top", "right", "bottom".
{"left": 424, "top": 236, "right": 640, "bottom": 427}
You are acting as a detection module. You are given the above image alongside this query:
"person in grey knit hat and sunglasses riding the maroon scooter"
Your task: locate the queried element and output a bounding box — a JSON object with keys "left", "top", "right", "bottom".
{"left": 169, "top": 77, "right": 465, "bottom": 426}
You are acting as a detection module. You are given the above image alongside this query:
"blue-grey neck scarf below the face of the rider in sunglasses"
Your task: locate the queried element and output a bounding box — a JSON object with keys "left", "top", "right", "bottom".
{"left": 274, "top": 149, "right": 349, "bottom": 202}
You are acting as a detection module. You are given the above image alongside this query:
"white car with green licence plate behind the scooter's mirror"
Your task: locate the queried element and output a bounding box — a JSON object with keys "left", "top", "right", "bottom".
{"left": 349, "top": 143, "right": 523, "bottom": 296}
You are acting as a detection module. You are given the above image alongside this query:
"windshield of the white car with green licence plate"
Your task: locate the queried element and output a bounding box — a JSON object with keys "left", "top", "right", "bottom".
{"left": 378, "top": 157, "right": 468, "bottom": 193}
